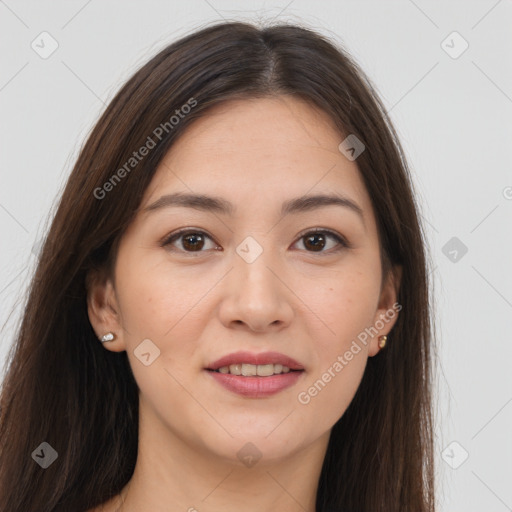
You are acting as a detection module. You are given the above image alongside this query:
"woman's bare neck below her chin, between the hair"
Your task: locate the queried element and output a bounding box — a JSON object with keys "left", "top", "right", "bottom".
{"left": 118, "top": 398, "right": 330, "bottom": 512}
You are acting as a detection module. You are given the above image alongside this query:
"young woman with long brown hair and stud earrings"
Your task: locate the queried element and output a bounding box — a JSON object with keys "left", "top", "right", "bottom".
{"left": 0, "top": 23, "right": 434, "bottom": 512}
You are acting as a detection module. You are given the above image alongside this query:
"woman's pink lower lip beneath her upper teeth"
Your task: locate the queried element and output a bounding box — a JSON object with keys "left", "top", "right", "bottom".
{"left": 206, "top": 370, "right": 304, "bottom": 398}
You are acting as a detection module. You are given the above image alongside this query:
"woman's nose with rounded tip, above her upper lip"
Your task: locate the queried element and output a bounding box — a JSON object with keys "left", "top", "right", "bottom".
{"left": 219, "top": 251, "right": 294, "bottom": 332}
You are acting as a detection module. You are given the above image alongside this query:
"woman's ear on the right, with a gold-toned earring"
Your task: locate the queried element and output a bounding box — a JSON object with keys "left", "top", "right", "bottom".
{"left": 368, "top": 265, "right": 403, "bottom": 357}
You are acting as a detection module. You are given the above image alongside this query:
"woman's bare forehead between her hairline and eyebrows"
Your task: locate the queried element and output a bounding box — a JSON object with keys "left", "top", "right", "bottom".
{"left": 143, "top": 96, "right": 371, "bottom": 221}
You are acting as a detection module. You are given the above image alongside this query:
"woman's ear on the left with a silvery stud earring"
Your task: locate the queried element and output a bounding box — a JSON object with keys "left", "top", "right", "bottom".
{"left": 85, "top": 270, "right": 126, "bottom": 352}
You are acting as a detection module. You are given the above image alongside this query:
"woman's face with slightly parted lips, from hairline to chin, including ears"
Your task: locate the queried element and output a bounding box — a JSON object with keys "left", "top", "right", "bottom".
{"left": 89, "top": 96, "right": 396, "bottom": 468}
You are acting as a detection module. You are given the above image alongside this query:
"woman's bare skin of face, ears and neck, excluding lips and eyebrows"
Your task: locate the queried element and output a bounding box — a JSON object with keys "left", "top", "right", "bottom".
{"left": 88, "top": 96, "right": 400, "bottom": 512}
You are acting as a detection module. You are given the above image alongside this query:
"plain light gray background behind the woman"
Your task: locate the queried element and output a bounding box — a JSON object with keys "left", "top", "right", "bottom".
{"left": 0, "top": 0, "right": 512, "bottom": 512}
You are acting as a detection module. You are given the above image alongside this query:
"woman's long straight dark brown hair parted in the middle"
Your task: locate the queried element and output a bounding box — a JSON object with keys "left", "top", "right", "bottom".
{"left": 0, "top": 23, "right": 435, "bottom": 512}
